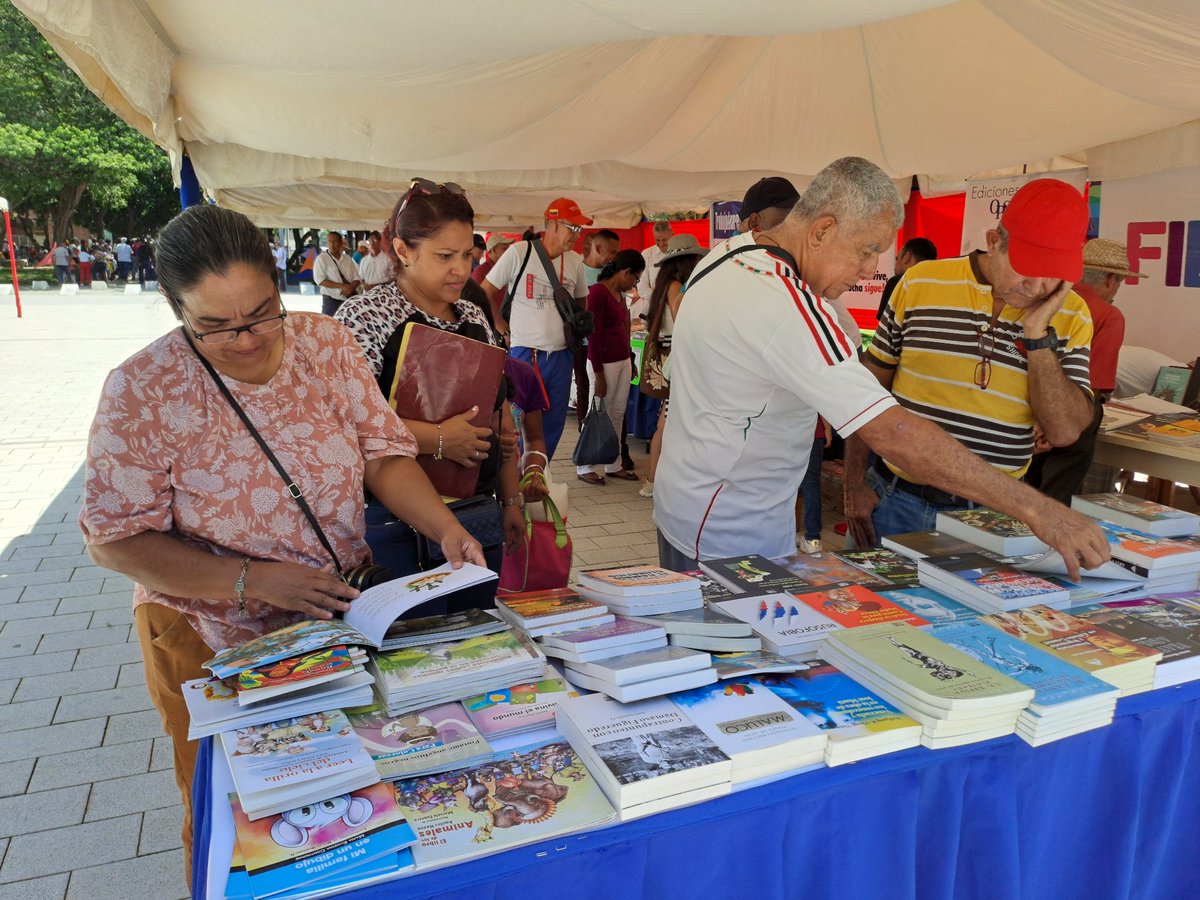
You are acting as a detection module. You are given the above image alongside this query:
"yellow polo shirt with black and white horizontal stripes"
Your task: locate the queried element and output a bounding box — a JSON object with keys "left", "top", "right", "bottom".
{"left": 868, "top": 257, "right": 1092, "bottom": 480}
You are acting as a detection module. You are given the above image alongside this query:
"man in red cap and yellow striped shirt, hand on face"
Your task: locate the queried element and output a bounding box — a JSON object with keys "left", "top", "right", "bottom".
{"left": 845, "top": 179, "right": 1093, "bottom": 547}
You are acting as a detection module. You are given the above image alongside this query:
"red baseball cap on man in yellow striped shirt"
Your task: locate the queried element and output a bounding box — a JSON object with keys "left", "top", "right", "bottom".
{"left": 1000, "top": 178, "right": 1090, "bottom": 282}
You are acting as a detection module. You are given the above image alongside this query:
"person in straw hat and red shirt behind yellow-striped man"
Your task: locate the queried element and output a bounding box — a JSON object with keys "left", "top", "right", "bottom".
{"left": 1025, "top": 238, "right": 1146, "bottom": 503}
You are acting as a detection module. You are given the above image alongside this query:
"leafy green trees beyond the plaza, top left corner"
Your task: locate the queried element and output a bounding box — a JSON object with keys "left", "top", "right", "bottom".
{"left": 0, "top": 0, "right": 179, "bottom": 244}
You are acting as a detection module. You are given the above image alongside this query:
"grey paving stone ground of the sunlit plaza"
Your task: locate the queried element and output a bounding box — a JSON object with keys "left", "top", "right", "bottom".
{"left": 0, "top": 290, "right": 833, "bottom": 900}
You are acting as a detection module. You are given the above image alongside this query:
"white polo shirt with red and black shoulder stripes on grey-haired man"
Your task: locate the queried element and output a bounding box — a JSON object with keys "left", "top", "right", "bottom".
{"left": 654, "top": 234, "right": 895, "bottom": 559}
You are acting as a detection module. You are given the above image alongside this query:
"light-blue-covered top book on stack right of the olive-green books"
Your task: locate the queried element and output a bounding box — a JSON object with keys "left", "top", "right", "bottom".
{"left": 929, "top": 619, "right": 1118, "bottom": 713}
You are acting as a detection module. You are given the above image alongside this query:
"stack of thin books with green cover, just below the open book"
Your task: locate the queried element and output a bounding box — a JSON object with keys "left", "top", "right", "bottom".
{"left": 368, "top": 629, "right": 546, "bottom": 715}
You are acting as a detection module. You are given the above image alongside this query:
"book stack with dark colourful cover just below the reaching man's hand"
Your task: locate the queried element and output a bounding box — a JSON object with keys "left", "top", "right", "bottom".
{"left": 917, "top": 552, "right": 1070, "bottom": 613}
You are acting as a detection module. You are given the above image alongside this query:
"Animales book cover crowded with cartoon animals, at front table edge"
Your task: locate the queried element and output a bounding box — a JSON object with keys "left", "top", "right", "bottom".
{"left": 396, "top": 738, "right": 616, "bottom": 866}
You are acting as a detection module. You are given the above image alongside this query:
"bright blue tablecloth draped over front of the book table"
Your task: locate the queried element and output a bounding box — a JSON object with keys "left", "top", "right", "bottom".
{"left": 194, "top": 683, "right": 1200, "bottom": 900}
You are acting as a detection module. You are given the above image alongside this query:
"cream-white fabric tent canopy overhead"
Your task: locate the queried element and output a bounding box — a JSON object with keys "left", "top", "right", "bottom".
{"left": 14, "top": 0, "right": 1200, "bottom": 227}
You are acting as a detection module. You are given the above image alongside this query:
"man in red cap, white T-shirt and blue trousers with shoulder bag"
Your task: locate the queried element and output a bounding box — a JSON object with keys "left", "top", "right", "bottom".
{"left": 484, "top": 197, "right": 592, "bottom": 460}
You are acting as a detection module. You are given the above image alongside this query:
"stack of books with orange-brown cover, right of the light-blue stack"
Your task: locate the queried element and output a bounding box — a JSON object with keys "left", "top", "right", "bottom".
{"left": 983, "top": 606, "right": 1163, "bottom": 696}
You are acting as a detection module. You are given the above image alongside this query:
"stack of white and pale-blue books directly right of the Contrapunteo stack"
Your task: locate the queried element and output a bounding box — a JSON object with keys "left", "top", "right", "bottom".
{"left": 671, "top": 678, "right": 828, "bottom": 785}
